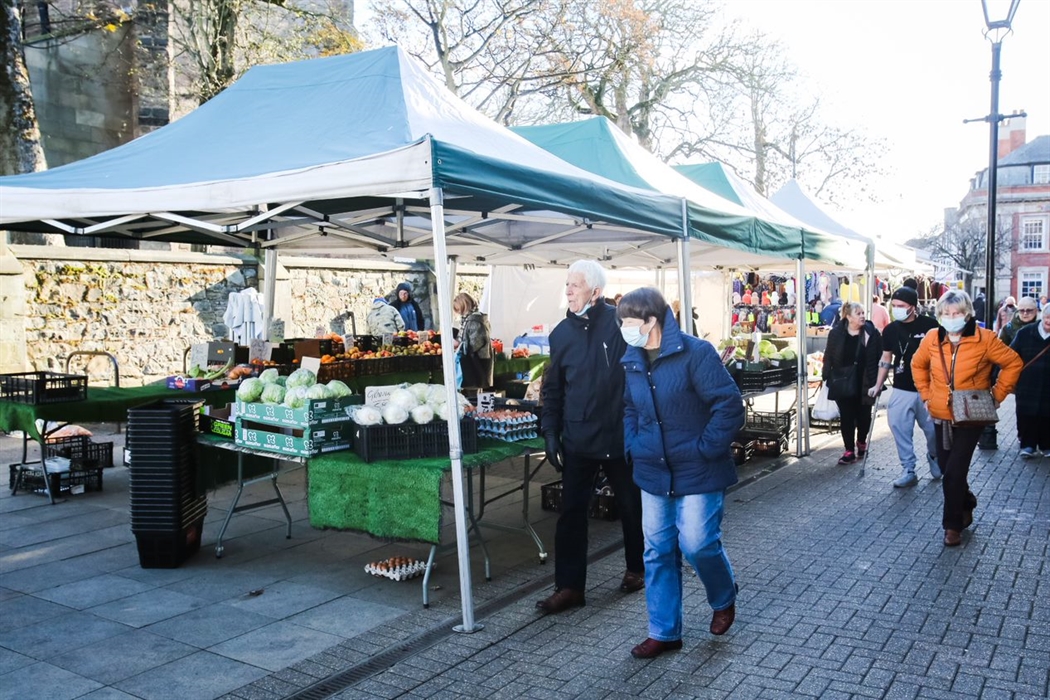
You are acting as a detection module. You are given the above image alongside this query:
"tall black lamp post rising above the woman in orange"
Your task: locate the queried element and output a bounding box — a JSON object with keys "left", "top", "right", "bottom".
{"left": 981, "top": 0, "right": 1021, "bottom": 328}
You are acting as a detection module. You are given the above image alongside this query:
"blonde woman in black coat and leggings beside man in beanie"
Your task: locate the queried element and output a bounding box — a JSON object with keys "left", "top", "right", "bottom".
{"left": 823, "top": 301, "right": 882, "bottom": 464}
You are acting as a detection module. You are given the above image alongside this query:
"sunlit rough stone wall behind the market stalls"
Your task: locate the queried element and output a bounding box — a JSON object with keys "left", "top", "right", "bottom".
{"left": 0, "top": 246, "right": 487, "bottom": 386}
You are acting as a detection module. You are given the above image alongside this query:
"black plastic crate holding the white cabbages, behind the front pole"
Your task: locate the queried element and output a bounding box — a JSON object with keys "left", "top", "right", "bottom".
{"left": 353, "top": 418, "right": 478, "bottom": 462}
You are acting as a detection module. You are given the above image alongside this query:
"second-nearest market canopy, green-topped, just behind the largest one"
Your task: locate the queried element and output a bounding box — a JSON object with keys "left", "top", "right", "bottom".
{"left": 513, "top": 116, "right": 864, "bottom": 268}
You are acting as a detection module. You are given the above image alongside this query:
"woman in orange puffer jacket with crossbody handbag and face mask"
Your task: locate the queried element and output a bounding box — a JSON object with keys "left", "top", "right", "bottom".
{"left": 911, "top": 290, "right": 1024, "bottom": 547}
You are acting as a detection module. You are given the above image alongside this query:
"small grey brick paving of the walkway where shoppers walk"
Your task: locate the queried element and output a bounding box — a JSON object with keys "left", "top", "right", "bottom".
{"left": 289, "top": 401, "right": 1050, "bottom": 700}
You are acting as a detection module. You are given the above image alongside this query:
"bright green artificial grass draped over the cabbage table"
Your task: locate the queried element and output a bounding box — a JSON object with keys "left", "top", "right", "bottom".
{"left": 308, "top": 439, "right": 543, "bottom": 544}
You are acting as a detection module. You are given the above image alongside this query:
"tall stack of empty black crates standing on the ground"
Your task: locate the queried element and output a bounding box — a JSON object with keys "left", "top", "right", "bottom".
{"left": 127, "top": 400, "right": 208, "bottom": 569}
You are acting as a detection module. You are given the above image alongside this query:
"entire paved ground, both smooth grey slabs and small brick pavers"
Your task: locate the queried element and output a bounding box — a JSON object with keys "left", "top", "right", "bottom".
{"left": 0, "top": 399, "right": 1050, "bottom": 700}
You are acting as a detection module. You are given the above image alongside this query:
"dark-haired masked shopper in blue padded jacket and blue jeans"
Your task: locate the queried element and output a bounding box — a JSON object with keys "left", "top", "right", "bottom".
{"left": 616, "top": 288, "right": 743, "bottom": 659}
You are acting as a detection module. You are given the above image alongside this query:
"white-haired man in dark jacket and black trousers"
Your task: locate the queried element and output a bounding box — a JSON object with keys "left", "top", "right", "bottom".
{"left": 537, "top": 260, "right": 645, "bottom": 613}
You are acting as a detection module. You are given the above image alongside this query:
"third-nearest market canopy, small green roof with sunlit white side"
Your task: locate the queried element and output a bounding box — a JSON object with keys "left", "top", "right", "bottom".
{"left": 674, "top": 162, "right": 869, "bottom": 270}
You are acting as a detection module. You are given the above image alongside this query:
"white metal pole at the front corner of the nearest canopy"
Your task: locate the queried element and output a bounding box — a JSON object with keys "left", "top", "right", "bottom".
{"left": 431, "top": 187, "right": 482, "bottom": 633}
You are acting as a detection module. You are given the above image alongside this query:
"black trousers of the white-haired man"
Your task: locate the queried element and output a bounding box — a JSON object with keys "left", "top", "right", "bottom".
{"left": 554, "top": 454, "right": 645, "bottom": 591}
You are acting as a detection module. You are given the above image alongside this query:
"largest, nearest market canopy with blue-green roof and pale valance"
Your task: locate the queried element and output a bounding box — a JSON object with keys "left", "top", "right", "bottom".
{"left": 0, "top": 46, "right": 713, "bottom": 267}
